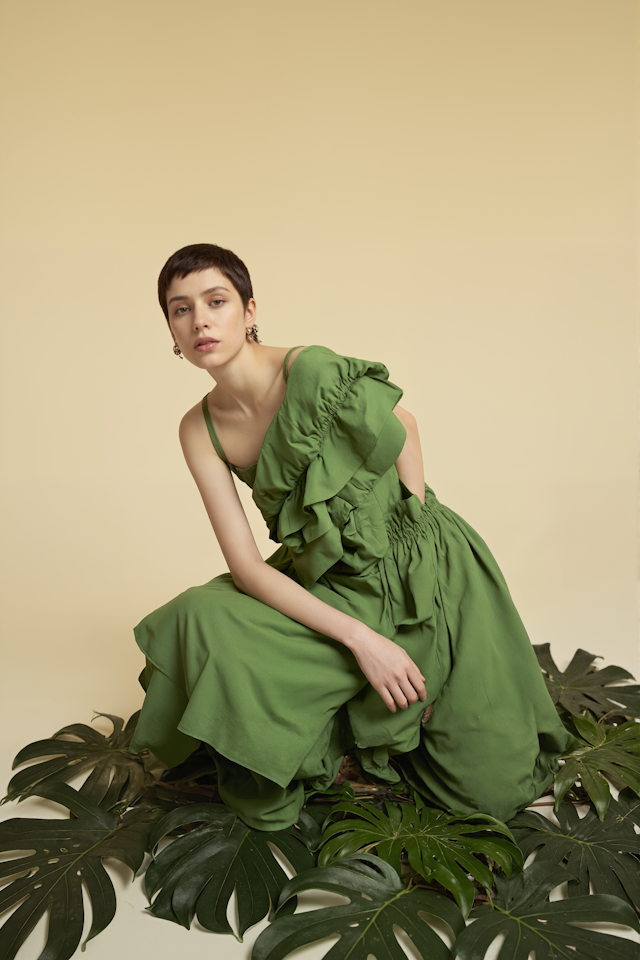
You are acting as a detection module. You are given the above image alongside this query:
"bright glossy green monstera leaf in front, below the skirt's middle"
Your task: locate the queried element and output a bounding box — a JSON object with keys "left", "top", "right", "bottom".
{"left": 318, "top": 803, "right": 523, "bottom": 916}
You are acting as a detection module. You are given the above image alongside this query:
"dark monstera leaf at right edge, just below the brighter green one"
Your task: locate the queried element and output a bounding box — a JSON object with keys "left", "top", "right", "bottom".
{"left": 509, "top": 800, "right": 640, "bottom": 909}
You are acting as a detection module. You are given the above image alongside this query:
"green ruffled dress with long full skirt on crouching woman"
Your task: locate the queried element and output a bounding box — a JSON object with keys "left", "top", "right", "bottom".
{"left": 131, "top": 345, "right": 568, "bottom": 830}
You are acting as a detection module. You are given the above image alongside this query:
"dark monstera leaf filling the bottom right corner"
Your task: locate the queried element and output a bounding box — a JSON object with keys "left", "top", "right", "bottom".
{"left": 454, "top": 862, "right": 638, "bottom": 960}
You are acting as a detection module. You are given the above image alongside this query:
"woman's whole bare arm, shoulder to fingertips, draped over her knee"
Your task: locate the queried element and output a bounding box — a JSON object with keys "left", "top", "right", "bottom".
{"left": 180, "top": 405, "right": 426, "bottom": 712}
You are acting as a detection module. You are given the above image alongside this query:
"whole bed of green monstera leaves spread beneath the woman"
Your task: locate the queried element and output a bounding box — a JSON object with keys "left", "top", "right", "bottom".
{"left": 0, "top": 644, "right": 640, "bottom": 960}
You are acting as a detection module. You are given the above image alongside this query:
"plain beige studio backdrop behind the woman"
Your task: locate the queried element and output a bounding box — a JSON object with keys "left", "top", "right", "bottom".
{"left": 0, "top": 0, "right": 637, "bottom": 958}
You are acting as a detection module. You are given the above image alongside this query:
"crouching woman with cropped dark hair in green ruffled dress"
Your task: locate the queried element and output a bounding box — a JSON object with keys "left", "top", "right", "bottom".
{"left": 131, "top": 244, "right": 567, "bottom": 830}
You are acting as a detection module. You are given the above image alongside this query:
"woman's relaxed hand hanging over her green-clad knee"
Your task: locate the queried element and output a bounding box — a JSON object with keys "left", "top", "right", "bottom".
{"left": 349, "top": 630, "right": 427, "bottom": 713}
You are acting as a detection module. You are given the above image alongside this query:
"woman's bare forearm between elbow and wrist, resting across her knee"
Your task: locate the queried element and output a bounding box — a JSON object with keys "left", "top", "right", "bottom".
{"left": 234, "top": 560, "right": 369, "bottom": 649}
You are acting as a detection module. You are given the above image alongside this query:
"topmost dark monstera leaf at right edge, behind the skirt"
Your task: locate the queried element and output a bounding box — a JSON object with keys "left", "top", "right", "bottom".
{"left": 533, "top": 643, "right": 640, "bottom": 717}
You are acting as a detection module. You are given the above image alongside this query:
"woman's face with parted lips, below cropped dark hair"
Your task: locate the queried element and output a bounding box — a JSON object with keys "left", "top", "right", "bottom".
{"left": 167, "top": 267, "right": 256, "bottom": 370}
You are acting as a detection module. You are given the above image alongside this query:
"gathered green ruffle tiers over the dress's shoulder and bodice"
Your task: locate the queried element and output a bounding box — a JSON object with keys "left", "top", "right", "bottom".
{"left": 253, "top": 345, "right": 406, "bottom": 587}
